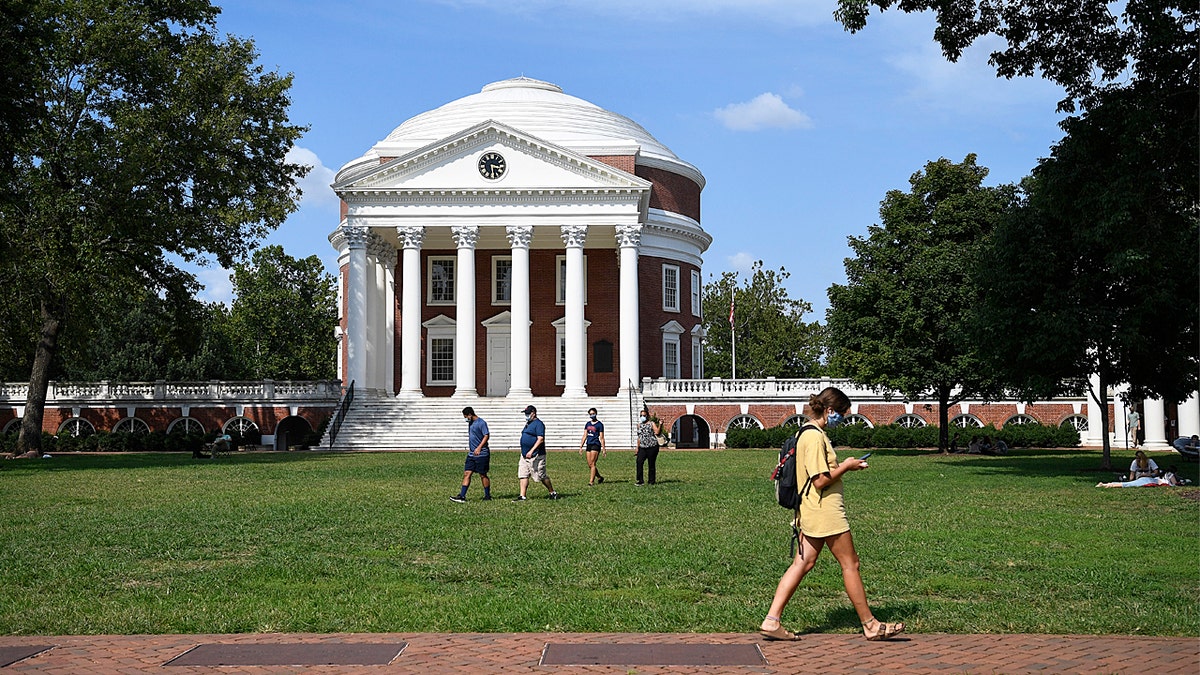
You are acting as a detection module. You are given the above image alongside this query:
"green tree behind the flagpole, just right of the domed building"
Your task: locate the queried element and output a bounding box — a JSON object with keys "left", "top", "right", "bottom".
{"left": 703, "top": 261, "right": 823, "bottom": 377}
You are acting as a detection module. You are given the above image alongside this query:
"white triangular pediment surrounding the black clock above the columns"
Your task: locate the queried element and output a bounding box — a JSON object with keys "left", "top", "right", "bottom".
{"left": 334, "top": 121, "right": 650, "bottom": 195}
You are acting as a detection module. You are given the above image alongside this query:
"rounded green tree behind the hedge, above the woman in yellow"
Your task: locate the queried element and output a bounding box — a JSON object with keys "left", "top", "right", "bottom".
{"left": 827, "top": 155, "right": 1015, "bottom": 452}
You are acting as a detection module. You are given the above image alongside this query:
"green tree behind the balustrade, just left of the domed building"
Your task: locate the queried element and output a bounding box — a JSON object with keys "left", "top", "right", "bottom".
{"left": 229, "top": 246, "right": 337, "bottom": 380}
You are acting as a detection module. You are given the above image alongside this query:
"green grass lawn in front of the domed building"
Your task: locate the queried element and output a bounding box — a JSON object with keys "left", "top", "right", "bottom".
{"left": 0, "top": 449, "right": 1200, "bottom": 635}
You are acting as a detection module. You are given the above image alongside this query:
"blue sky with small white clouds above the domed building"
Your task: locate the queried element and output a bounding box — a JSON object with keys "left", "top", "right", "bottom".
{"left": 200, "top": 0, "right": 1062, "bottom": 322}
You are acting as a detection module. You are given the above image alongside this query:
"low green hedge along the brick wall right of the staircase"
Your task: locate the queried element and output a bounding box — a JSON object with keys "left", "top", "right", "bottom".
{"left": 725, "top": 424, "right": 1079, "bottom": 450}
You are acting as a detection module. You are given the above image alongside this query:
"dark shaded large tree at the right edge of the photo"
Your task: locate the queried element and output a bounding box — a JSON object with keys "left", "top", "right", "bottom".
{"left": 979, "top": 85, "right": 1200, "bottom": 468}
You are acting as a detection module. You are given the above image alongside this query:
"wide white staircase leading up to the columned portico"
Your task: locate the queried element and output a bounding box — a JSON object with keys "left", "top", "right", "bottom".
{"left": 320, "top": 394, "right": 642, "bottom": 452}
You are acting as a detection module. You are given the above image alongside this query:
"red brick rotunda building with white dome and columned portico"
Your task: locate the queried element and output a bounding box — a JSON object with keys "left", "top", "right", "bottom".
{"left": 330, "top": 77, "right": 712, "bottom": 399}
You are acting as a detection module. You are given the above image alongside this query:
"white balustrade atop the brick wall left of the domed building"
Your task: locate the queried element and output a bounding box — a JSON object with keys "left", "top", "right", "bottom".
{"left": 0, "top": 380, "right": 342, "bottom": 406}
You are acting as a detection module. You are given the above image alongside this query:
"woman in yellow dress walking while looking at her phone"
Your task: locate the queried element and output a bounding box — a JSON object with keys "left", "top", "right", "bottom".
{"left": 758, "top": 387, "right": 904, "bottom": 640}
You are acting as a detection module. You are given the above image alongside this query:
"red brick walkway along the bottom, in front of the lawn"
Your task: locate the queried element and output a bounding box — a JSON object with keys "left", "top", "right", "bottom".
{"left": 0, "top": 633, "right": 1200, "bottom": 675}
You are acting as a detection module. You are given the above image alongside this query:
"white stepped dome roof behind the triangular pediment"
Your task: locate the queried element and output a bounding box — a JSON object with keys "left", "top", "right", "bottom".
{"left": 343, "top": 77, "right": 703, "bottom": 185}
